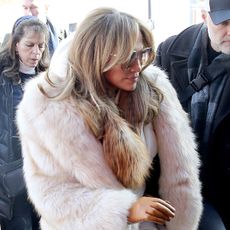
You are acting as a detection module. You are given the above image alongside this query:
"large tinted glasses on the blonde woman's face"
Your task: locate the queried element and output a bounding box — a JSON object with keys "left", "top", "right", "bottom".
{"left": 122, "top": 47, "right": 153, "bottom": 69}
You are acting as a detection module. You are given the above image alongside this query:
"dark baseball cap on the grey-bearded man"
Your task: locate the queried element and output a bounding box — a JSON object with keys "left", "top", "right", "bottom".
{"left": 209, "top": 0, "right": 230, "bottom": 25}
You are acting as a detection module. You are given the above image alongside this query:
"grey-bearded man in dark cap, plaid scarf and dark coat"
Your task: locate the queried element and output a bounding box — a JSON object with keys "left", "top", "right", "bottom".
{"left": 155, "top": 0, "right": 230, "bottom": 230}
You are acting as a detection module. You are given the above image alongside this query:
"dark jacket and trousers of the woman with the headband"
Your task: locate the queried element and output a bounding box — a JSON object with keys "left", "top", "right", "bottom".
{"left": 0, "top": 63, "right": 37, "bottom": 230}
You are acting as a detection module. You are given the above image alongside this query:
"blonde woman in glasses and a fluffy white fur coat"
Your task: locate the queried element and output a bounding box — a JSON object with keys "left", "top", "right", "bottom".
{"left": 17, "top": 8, "right": 202, "bottom": 230}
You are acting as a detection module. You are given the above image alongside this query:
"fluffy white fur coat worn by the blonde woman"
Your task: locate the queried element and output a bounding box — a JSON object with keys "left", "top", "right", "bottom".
{"left": 17, "top": 37, "right": 202, "bottom": 230}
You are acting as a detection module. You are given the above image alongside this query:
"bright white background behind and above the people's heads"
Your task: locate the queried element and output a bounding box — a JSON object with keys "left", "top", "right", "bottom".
{"left": 0, "top": 0, "right": 202, "bottom": 45}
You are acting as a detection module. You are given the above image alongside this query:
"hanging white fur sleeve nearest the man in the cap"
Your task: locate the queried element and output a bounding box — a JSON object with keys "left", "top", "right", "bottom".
{"left": 146, "top": 67, "right": 202, "bottom": 230}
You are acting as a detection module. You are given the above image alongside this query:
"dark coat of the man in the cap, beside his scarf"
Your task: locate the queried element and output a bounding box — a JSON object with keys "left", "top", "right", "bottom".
{"left": 155, "top": 24, "right": 230, "bottom": 227}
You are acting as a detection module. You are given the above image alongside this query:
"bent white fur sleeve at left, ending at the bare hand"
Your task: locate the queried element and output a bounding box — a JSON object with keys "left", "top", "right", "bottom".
{"left": 17, "top": 77, "right": 136, "bottom": 230}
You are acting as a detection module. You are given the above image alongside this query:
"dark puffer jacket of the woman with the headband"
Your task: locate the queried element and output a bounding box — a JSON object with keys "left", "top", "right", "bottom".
{"left": 0, "top": 66, "right": 35, "bottom": 225}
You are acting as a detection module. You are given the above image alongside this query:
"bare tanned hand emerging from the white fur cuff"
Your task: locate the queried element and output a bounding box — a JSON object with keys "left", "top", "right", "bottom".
{"left": 128, "top": 196, "right": 175, "bottom": 225}
